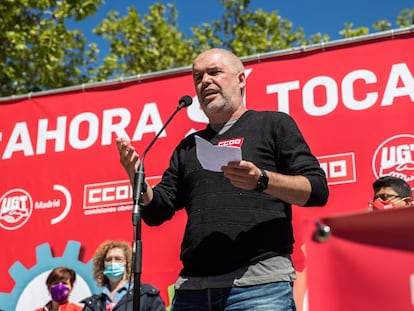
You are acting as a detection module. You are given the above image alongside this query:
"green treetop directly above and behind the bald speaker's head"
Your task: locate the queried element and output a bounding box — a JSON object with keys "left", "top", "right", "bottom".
{"left": 192, "top": 0, "right": 329, "bottom": 56}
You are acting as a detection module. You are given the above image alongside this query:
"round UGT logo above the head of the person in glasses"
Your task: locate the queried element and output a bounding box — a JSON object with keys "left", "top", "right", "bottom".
{"left": 372, "top": 134, "right": 414, "bottom": 188}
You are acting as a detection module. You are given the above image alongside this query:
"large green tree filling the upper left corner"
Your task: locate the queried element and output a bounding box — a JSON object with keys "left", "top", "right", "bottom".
{"left": 0, "top": 0, "right": 102, "bottom": 96}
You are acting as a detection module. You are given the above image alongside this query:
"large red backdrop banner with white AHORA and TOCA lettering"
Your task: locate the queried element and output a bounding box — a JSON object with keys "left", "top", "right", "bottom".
{"left": 0, "top": 32, "right": 414, "bottom": 311}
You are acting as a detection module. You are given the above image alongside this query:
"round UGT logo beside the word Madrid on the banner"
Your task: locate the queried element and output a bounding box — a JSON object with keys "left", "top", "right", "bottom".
{"left": 0, "top": 189, "right": 33, "bottom": 230}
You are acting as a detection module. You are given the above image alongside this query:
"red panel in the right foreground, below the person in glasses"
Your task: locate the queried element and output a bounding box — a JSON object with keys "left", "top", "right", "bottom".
{"left": 306, "top": 207, "right": 414, "bottom": 311}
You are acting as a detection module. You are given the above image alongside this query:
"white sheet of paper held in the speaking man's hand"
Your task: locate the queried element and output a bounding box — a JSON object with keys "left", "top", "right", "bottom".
{"left": 195, "top": 136, "right": 242, "bottom": 172}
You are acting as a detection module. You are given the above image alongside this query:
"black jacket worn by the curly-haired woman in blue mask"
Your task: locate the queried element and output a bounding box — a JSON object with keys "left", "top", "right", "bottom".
{"left": 81, "top": 284, "right": 165, "bottom": 311}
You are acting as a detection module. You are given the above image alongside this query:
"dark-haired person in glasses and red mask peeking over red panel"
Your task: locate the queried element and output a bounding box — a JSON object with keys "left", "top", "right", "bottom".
{"left": 368, "top": 176, "right": 413, "bottom": 210}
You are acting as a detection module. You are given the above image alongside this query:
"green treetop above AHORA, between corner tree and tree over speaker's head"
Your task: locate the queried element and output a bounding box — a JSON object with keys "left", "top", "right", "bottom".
{"left": 93, "top": 3, "right": 198, "bottom": 81}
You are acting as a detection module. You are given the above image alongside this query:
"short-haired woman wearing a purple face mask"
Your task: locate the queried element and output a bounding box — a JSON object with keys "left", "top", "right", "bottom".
{"left": 35, "top": 267, "right": 82, "bottom": 311}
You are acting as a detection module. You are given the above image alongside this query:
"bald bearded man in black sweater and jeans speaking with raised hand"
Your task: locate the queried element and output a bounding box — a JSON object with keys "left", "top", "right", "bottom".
{"left": 117, "top": 49, "right": 329, "bottom": 311}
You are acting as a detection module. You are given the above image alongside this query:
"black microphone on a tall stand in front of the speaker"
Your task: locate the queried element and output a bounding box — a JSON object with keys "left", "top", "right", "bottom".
{"left": 132, "top": 95, "right": 193, "bottom": 311}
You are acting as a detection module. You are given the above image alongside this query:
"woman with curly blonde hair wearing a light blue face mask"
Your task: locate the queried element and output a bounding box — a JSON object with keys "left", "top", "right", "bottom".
{"left": 81, "top": 241, "right": 165, "bottom": 311}
